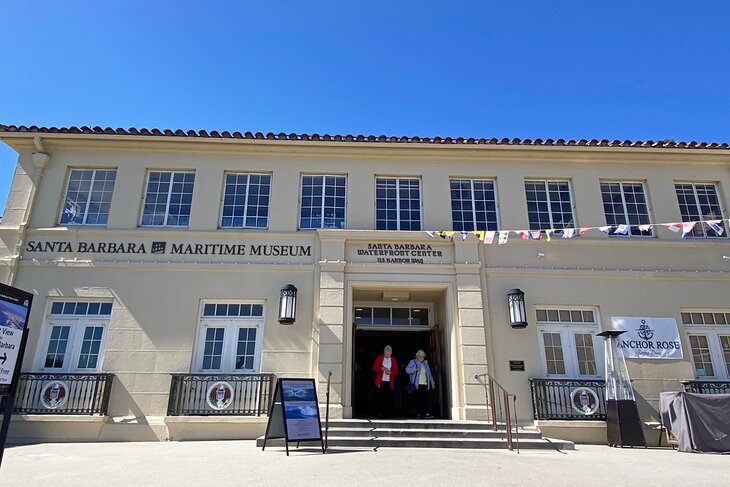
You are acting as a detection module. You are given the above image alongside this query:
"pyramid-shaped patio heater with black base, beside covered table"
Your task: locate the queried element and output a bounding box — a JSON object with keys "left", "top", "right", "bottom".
{"left": 598, "top": 330, "right": 646, "bottom": 448}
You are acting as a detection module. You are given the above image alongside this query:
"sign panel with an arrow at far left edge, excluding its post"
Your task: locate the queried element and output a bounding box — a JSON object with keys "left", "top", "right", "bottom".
{"left": 0, "top": 284, "right": 33, "bottom": 395}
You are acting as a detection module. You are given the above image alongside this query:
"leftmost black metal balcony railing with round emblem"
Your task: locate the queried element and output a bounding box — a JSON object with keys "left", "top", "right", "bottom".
{"left": 0, "top": 373, "right": 114, "bottom": 416}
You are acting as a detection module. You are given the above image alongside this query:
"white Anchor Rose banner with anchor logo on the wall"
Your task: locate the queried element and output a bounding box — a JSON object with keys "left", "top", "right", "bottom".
{"left": 611, "top": 316, "right": 683, "bottom": 359}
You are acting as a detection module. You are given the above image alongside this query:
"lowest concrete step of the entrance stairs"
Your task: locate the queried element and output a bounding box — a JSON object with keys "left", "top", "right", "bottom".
{"left": 256, "top": 436, "right": 575, "bottom": 450}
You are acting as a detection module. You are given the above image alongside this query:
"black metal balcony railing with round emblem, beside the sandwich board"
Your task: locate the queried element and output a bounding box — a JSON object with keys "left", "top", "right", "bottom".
{"left": 167, "top": 374, "right": 274, "bottom": 416}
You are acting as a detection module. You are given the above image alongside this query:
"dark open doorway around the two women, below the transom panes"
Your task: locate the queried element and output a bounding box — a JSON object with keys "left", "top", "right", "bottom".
{"left": 352, "top": 326, "right": 446, "bottom": 418}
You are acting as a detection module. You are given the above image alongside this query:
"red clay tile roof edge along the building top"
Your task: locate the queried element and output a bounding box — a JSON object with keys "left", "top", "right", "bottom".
{"left": 0, "top": 124, "right": 730, "bottom": 150}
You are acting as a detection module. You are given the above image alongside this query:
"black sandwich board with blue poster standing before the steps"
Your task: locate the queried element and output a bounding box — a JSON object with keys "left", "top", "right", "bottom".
{"left": 261, "top": 379, "right": 325, "bottom": 456}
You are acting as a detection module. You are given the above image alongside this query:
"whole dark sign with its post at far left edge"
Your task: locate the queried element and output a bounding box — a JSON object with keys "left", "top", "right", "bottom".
{"left": 0, "top": 283, "right": 33, "bottom": 466}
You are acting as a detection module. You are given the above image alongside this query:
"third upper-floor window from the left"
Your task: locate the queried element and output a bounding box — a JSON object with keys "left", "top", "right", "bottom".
{"left": 221, "top": 173, "right": 271, "bottom": 228}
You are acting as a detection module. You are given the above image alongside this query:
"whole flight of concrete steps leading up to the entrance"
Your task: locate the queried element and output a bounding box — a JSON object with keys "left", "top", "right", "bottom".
{"left": 256, "top": 419, "right": 575, "bottom": 450}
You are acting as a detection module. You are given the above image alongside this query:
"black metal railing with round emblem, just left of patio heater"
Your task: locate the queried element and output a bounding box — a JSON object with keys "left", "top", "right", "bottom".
{"left": 530, "top": 378, "right": 606, "bottom": 421}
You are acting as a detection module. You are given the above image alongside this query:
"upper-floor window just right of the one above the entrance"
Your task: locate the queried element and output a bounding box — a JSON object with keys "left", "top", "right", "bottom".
{"left": 450, "top": 178, "right": 499, "bottom": 232}
